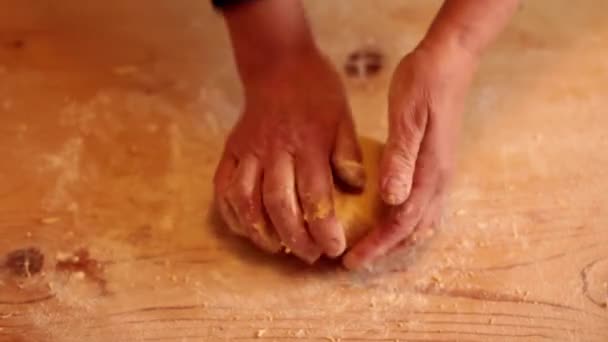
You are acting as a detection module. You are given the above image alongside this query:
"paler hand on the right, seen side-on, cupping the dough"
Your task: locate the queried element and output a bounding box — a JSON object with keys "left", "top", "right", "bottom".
{"left": 343, "top": 44, "right": 477, "bottom": 269}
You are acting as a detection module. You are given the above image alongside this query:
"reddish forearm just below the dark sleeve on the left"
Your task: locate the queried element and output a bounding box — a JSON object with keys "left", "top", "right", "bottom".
{"left": 224, "top": 0, "right": 316, "bottom": 80}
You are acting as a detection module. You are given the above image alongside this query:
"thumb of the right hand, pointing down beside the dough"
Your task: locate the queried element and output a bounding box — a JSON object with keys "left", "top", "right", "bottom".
{"left": 380, "top": 104, "right": 427, "bottom": 205}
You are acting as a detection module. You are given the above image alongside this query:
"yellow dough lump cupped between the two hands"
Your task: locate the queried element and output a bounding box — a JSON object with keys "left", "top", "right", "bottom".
{"left": 334, "top": 138, "right": 383, "bottom": 246}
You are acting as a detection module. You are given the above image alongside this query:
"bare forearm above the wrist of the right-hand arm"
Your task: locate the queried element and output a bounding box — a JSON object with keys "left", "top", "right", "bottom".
{"left": 421, "top": 0, "right": 519, "bottom": 57}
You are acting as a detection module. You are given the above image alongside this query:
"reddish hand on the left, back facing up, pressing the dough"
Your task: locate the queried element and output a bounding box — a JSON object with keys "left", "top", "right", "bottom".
{"left": 214, "top": 51, "right": 365, "bottom": 263}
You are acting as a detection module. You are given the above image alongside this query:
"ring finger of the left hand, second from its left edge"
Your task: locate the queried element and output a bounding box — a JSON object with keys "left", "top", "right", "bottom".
{"left": 226, "top": 155, "right": 281, "bottom": 253}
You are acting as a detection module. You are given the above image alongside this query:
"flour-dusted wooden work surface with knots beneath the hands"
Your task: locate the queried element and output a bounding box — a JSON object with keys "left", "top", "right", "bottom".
{"left": 0, "top": 0, "right": 608, "bottom": 342}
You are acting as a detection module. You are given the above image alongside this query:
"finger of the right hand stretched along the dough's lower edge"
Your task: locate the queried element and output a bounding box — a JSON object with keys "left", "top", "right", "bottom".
{"left": 343, "top": 180, "right": 435, "bottom": 269}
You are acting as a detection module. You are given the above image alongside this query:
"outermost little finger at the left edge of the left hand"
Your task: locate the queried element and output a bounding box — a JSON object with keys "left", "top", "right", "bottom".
{"left": 213, "top": 152, "right": 247, "bottom": 236}
